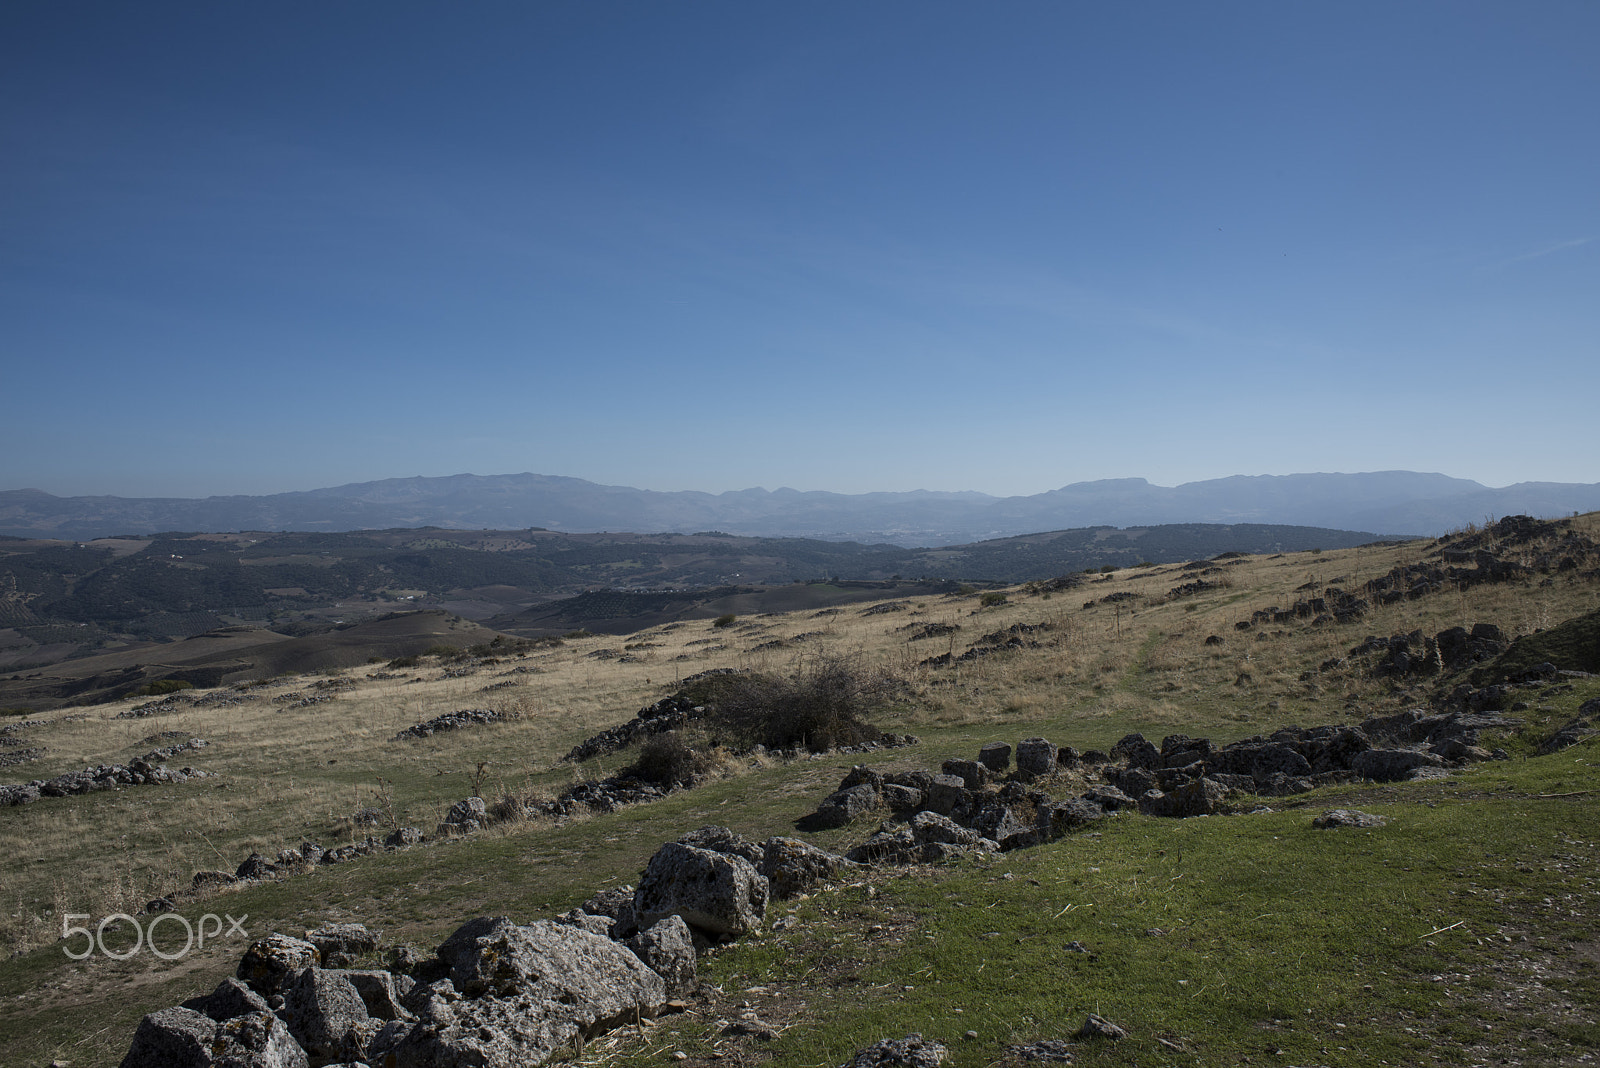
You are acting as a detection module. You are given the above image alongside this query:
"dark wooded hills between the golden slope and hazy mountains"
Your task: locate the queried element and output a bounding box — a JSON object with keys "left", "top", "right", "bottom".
{"left": 0, "top": 524, "right": 1371, "bottom": 697}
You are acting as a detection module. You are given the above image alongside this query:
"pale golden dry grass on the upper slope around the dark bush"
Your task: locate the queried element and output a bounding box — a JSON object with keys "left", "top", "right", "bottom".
{"left": 0, "top": 515, "right": 1600, "bottom": 950}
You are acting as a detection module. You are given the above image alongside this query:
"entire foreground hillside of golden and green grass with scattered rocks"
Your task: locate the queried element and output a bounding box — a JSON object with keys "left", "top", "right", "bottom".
{"left": 0, "top": 515, "right": 1600, "bottom": 1068}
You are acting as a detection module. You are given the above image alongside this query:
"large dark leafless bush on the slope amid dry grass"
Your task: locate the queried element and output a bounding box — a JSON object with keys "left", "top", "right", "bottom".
{"left": 715, "top": 657, "right": 902, "bottom": 753}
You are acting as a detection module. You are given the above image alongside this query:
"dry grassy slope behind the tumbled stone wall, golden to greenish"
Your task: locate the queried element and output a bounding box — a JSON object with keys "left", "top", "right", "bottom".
{"left": 0, "top": 515, "right": 1600, "bottom": 1065}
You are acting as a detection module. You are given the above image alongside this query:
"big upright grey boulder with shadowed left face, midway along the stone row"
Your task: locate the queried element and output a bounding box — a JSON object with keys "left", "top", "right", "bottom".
{"left": 634, "top": 843, "right": 768, "bottom": 938}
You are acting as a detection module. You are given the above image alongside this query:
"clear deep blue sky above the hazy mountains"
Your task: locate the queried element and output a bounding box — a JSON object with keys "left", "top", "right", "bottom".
{"left": 0, "top": 0, "right": 1600, "bottom": 496}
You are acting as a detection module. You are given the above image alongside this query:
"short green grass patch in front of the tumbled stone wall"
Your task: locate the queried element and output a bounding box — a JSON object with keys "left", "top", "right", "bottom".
{"left": 637, "top": 745, "right": 1600, "bottom": 1066}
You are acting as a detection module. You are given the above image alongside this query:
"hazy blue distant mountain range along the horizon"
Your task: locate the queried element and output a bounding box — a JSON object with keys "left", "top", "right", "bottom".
{"left": 0, "top": 472, "right": 1600, "bottom": 547}
